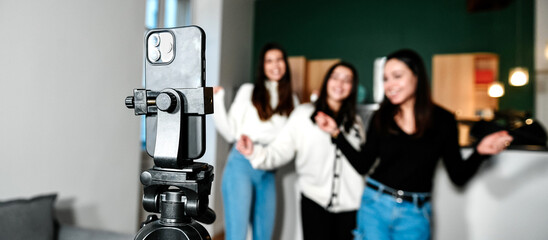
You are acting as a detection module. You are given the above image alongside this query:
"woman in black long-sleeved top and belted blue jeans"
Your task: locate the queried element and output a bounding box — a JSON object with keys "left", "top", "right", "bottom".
{"left": 316, "top": 50, "right": 512, "bottom": 239}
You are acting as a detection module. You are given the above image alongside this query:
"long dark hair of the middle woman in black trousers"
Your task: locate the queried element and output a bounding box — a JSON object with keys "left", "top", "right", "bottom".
{"left": 312, "top": 62, "right": 358, "bottom": 132}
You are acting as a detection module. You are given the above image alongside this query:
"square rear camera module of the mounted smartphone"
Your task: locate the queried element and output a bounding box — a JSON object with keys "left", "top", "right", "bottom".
{"left": 147, "top": 31, "right": 174, "bottom": 64}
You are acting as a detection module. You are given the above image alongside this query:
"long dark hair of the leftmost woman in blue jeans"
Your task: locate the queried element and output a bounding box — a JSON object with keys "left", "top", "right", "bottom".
{"left": 251, "top": 43, "right": 295, "bottom": 121}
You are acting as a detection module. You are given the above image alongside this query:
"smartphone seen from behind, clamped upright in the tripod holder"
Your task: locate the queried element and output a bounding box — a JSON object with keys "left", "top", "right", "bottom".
{"left": 144, "top": 26, "right": 205, "bottom": 160}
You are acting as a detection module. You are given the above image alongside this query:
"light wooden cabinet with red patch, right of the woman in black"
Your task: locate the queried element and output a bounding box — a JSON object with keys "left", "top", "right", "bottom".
{"left": 432, "top": 53, "right": 499, "bottom": 145}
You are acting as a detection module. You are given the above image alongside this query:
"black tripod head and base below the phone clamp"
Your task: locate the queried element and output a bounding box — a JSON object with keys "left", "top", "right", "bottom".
{"left": 135, "top": 163, "right": 215, "bottom": 240}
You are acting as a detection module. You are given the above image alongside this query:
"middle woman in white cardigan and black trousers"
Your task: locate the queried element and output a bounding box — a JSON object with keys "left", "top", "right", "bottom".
{"left": 236, "top": 63, "right": 364, "bottom": 240}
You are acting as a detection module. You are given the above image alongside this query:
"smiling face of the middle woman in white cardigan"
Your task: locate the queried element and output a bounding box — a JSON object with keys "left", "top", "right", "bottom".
{"left": 327, "top": 66, "right": 354, "bottom": 103}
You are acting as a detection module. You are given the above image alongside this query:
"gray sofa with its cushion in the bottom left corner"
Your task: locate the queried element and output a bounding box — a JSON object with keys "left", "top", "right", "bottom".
{"left": 0, "top": 194, "right": 134, "bottom": 240}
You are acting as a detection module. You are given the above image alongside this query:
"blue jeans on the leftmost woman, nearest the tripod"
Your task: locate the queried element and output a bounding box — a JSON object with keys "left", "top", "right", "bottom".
{"left": 221, "top": 148, "right": 276, "bottom": 240}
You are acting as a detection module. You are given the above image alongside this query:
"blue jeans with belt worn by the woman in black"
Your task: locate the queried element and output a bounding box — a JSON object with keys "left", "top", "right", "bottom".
{"left": 354, "top": 179, "right": 432, "bottom": 240}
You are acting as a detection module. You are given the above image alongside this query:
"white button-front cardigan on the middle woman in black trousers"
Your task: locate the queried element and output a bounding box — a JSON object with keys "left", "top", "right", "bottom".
{"left": 247, "top": 104, "right": 365, "bottom": 212}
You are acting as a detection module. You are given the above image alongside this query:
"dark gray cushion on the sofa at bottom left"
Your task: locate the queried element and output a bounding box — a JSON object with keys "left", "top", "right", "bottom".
{"left": 0, "top": 194, "right": 57, "bottom": 240}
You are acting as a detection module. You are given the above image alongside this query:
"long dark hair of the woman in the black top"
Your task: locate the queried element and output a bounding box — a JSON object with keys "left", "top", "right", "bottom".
{"left": 375, "top": 49, "right": 434, "bottom": 136}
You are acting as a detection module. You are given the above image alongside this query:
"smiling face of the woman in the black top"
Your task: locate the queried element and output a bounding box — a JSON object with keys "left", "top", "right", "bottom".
{"left": 384, "top": 58, "right": 417, "bottom": 105}
